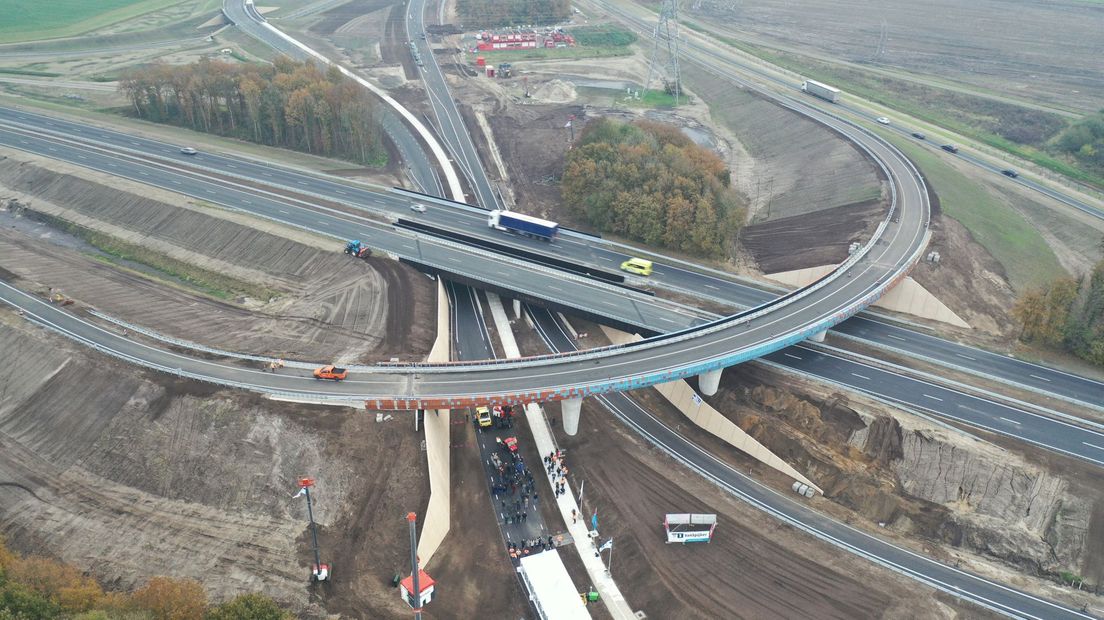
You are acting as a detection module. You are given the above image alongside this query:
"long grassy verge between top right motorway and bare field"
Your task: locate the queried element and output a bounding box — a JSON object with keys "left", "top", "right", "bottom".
{"left": 686, "top": 23, "right": 1104, "bottom": 189}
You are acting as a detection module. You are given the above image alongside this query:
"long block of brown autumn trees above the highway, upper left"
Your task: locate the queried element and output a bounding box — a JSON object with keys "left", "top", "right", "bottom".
{"left": 119, "top": 57, "right": 386, "bottom": 164}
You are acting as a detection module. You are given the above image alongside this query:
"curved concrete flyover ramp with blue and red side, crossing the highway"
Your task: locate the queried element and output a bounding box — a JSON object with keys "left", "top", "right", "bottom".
{"left": 0, "top": 97, "right": 930, "bottom": 429}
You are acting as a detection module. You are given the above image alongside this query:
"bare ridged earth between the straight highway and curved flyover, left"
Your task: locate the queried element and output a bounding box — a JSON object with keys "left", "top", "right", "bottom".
{"left": 0, "top": 153, "right": 436, "bottom": 361}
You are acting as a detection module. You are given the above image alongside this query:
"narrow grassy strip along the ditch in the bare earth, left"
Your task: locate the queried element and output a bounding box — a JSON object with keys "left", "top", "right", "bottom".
{"left": 28, "top": 210, "right": 279, "bottom": 301}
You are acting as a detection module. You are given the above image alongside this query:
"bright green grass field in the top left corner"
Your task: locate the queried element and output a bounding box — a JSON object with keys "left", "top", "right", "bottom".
{"left": 0, "top": 0, "right": 185, "bottom": 43}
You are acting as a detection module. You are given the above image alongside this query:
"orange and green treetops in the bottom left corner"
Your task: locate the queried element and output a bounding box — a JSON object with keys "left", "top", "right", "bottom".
{"left": 0, "top": 539, "right": 294, "bottom": 620}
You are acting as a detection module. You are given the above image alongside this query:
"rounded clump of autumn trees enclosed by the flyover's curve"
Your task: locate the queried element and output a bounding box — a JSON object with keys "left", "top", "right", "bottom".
{"left": 560, "top": 119, "right": 745, "bottom": 258}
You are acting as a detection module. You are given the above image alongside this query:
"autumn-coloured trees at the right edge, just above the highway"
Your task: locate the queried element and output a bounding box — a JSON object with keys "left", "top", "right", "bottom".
{"left": 1012, "top": 260, "right": 1104, "bottom": 366}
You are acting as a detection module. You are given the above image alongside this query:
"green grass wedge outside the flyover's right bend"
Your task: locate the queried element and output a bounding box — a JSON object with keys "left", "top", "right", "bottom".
{"left": 883, "top": 133, "right": 1069, "bottom": 291}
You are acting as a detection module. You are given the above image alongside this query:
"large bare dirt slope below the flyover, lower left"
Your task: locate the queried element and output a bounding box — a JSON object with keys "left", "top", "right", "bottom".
{"left": 0, "top": 310, "right": 428, "bottom": 617}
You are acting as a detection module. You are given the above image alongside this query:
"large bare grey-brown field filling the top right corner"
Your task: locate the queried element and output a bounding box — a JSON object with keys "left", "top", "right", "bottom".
{"left": 683, "top": 0, "right": 1104, "bottom": 111}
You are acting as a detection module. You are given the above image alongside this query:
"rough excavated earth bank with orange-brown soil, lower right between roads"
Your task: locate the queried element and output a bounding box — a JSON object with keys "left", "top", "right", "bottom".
{"left": 710, "top": 365, "right": 1104, "bottom": 586}
